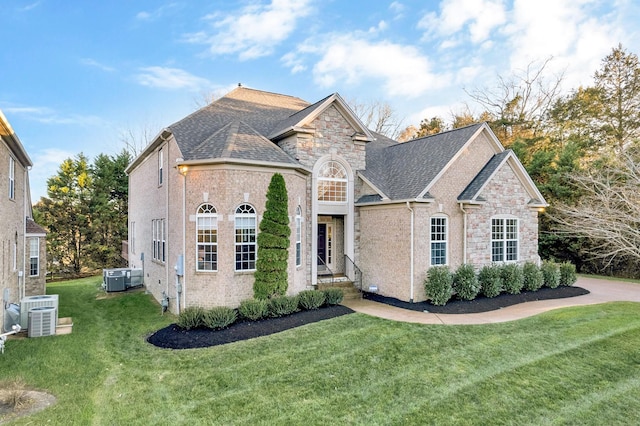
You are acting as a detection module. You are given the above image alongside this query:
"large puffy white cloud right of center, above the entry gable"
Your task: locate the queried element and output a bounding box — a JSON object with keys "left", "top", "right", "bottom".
{"left": 298, "top": 34, "right": 449, "bottom": 97}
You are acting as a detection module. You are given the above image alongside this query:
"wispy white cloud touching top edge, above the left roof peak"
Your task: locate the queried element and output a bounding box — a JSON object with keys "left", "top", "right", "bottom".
{"left": 184, "top": 0, "right": 311, "bottom": 60}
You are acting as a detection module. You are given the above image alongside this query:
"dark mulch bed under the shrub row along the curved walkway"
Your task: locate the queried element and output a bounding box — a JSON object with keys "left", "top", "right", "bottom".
{"left": 363, "top": 286, "right": 589, "bottom": 314}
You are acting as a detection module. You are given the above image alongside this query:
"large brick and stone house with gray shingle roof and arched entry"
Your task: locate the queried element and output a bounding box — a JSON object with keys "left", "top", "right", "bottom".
{"left": 127, "top": 87, "right": 547, "bottom": 311}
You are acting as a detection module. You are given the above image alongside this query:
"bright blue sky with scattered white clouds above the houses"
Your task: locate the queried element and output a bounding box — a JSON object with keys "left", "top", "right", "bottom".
{"left": 0, "top": 0, "right": 640, "bottom": 202}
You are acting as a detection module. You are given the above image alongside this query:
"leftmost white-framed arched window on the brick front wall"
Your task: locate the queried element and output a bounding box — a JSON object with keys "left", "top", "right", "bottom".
{"left": 196, "top": 204, "right": 218, "bottom": 271}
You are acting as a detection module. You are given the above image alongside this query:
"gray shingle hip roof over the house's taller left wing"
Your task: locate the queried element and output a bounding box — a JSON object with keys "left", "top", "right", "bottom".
{"left": 169, "top": 87, "right": 309, "bottom": 162}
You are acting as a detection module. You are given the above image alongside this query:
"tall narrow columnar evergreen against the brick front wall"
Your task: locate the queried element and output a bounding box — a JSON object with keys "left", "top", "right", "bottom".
{"left": 253, "top": 173, "right": 291, "bottom": 299}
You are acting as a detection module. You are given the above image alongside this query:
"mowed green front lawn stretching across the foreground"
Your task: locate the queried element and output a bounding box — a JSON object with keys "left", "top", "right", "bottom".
{"left": 0, "top": 278, "right": 640, "bottom": 425}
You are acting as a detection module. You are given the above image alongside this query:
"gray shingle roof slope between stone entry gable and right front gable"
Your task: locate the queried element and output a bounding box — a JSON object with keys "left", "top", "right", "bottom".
{"left": 362, "top": 123, "right": 484, "bottom": 200}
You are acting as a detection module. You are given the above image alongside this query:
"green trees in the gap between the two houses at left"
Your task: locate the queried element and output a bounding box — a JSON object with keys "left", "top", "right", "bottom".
{"left": 33, "top": 150, "right": 131, "bottom": 275}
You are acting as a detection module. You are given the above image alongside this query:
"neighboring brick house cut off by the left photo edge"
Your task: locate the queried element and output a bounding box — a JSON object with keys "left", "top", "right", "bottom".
{"left": 0, "top": 111, "right": 46, "bottom": 330}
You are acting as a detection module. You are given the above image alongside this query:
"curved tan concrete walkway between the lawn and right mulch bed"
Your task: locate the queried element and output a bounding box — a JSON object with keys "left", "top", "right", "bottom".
{"left": 343, "top": 277, "right": 640, "bottom": 324}
